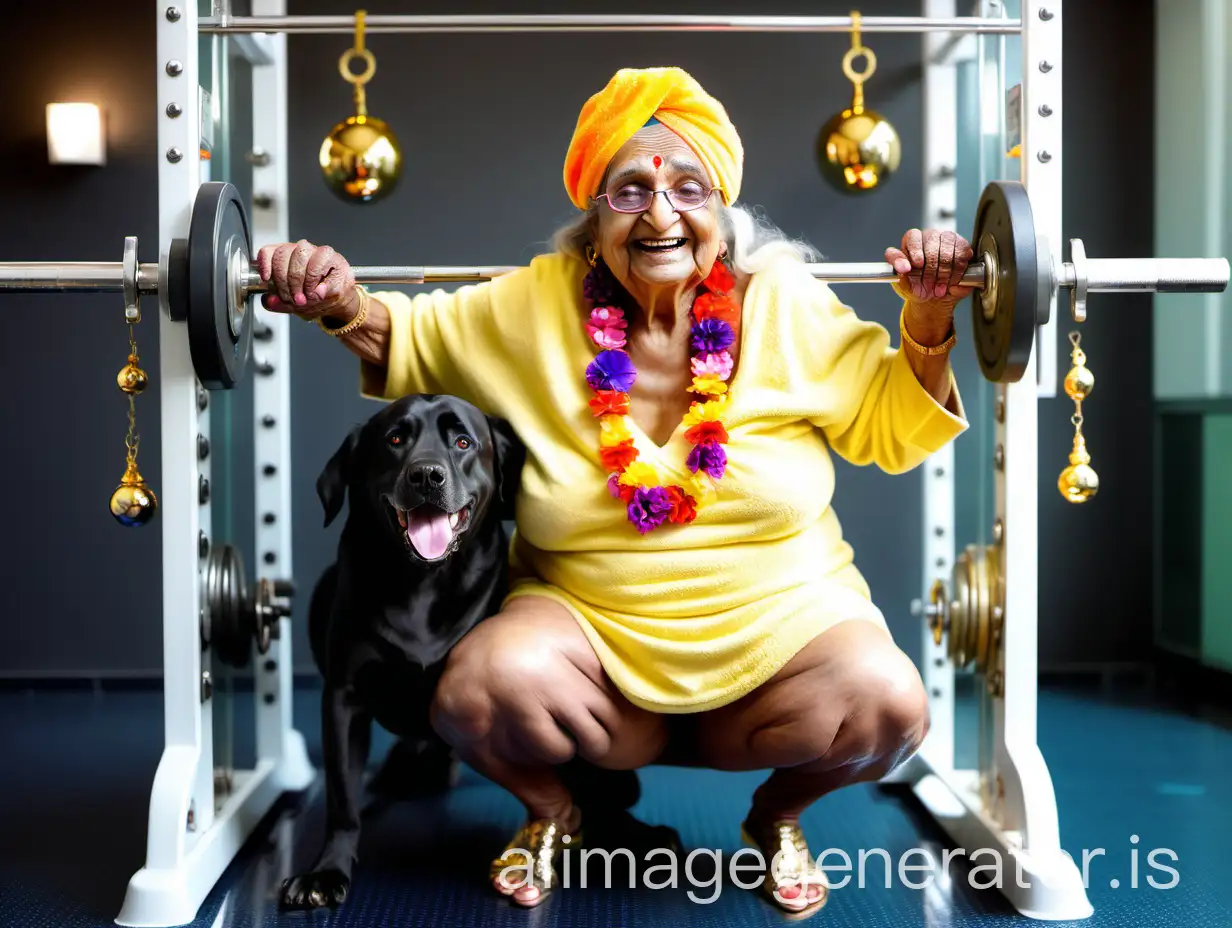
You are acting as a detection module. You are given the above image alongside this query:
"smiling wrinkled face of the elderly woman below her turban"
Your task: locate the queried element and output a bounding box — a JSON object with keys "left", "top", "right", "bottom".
{"left": 595, "top": 124, "right": 722, "bottom": 304}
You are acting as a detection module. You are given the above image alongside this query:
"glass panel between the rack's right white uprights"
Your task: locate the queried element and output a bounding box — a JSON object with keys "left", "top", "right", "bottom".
{"left": 951, "top": 0, "right": 1021, "bottom": 769}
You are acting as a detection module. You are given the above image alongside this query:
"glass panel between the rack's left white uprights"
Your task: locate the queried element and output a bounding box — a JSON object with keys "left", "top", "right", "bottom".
{"left": 200, "top": 18, "right": 256, "bottom": 805}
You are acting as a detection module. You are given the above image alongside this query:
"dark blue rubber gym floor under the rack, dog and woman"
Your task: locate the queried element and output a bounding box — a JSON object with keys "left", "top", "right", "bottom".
{"left": 0, "top": 675, "right": 1232, "bottom": 928}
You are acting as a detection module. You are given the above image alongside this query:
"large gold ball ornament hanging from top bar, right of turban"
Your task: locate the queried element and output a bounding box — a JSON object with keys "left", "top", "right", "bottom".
{"left": 817, "top": 10, "right": 902, "bottom": 193}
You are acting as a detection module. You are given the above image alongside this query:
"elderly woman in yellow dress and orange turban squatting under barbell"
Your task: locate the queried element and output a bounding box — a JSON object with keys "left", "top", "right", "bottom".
{"left": 259, "top": 68, "right": 972, "bottom": 912}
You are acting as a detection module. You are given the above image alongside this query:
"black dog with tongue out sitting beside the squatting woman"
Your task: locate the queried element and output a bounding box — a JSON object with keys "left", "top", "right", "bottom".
{"left": 282, "top": 394, "right": 525, "bottom": 908}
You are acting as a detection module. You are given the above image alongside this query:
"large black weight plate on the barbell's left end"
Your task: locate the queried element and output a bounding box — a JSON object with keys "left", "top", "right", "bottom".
{"left": 187, "top": 181, "right": 254, "bottom": 389}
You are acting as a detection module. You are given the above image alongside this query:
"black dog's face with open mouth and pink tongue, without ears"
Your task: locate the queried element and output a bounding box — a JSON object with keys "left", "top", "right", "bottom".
{"left": 365, "top": 397, "right": 498, "bottom": 561}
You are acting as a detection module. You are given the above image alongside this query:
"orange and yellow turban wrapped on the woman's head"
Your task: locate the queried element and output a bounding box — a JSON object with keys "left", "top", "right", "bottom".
{"left": 564, "top": 68, "right": 744, "bottom": 210}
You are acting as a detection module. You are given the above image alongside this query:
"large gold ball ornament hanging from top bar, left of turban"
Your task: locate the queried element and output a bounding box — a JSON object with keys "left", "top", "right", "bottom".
{"left": 319, "top": 10, "right": 402, "bottom": 203}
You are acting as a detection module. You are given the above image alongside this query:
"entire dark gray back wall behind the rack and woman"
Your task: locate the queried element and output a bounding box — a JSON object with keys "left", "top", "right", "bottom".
{"left": 0, "top": 0, "right": 1152, "bottom": 675}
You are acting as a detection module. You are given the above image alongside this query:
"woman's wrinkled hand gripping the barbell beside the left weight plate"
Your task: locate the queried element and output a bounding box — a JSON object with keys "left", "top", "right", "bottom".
{"left": 256, "top": 239, "right": 359, "bottom": 319}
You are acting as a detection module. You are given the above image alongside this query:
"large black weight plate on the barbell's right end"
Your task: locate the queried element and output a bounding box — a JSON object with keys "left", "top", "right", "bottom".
{"left": 971, "top": 180, "right": 1041, "bottom": 383}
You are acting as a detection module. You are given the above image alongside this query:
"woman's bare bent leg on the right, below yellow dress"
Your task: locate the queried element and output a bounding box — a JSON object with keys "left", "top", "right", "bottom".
{"left": 697, "top": 620, "right": 928, "bottom": 908}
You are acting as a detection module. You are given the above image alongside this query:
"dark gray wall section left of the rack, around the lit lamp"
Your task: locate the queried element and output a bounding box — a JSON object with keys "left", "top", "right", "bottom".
{"left": 0, "top": 0, "right": 163, "bottom": 674}
